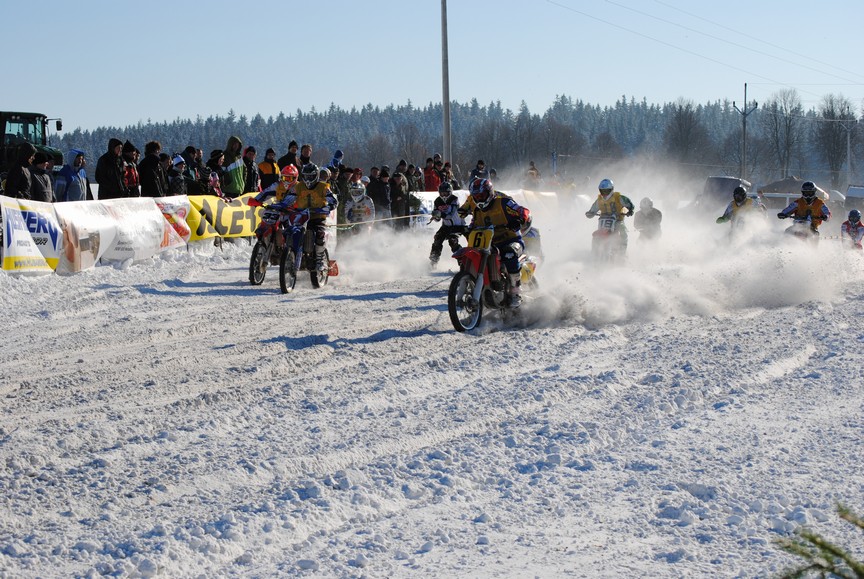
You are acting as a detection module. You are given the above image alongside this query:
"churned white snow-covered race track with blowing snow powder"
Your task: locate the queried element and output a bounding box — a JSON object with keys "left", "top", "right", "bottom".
{"left": 0, "top": 206, "right": 864, "bottom": 577}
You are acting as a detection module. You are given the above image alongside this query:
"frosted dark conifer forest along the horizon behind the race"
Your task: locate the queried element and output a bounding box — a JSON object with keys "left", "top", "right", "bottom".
{"left": 52, "top": 90, "right": 864, "bottom": 189}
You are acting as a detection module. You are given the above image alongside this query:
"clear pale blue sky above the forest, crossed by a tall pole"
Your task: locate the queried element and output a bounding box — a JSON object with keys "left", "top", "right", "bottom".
{"left": 8, "top": 0, "right": 864, "bottom": 130}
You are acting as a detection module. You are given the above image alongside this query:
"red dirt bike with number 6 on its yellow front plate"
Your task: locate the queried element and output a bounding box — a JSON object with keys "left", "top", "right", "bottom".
{"left": 447, "top": 223, "right": 536, "bottom": 332}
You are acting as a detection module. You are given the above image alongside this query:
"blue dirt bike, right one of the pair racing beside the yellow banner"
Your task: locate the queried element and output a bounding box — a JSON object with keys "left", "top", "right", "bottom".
{"left": 279, "top": 211, "right": 339, "bottom": 294}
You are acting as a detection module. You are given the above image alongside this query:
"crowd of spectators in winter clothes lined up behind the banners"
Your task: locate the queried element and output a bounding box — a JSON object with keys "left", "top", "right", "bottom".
{"left": 4, "top": 136, "right": 539, "bottom": 229}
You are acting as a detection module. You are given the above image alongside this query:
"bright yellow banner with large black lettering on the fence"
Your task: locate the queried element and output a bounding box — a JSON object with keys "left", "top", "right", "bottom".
{"left": 186, "top": 193, "right": 261, "bottom": 241}
